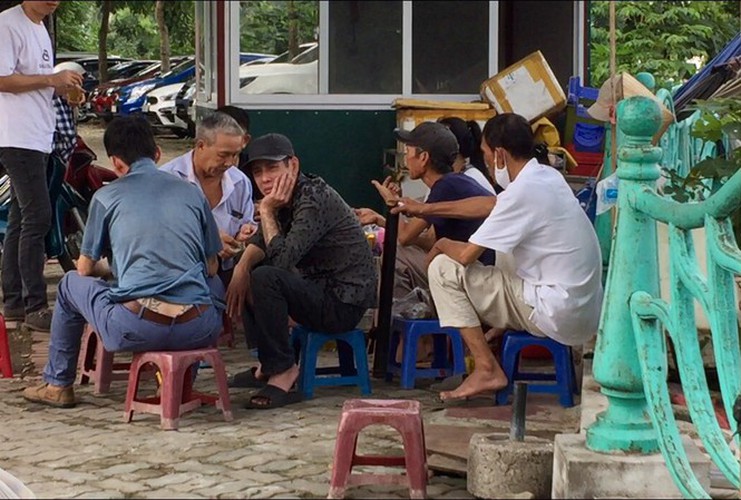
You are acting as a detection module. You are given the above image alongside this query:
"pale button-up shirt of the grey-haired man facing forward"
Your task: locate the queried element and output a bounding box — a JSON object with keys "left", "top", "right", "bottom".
{"left": 160, "top": 149, "right": 255, "bottom": 269}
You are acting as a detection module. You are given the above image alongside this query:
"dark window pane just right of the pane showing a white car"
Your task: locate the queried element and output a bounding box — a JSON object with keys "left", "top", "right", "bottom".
{"left": 329, "top": 0, "right": 402, "bottom": 94}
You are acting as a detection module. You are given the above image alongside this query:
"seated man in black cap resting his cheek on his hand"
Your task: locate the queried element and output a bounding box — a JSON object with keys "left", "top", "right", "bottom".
{"left": 227, "top": 134, "right": 378, "bottom": 409}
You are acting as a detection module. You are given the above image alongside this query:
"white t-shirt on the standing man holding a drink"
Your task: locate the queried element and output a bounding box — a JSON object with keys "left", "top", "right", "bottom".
{"left": 0, "top": 5, "right": 56, "bottom": 153}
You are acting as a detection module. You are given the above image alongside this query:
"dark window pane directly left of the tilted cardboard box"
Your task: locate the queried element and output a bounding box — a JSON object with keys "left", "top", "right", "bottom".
{"left": 412, "top": 1, "right": 489, "bottom": 94}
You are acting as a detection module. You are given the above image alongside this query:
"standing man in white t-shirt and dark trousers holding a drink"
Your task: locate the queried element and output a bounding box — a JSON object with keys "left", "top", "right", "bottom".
{"left": 0, "top": 1, "right": 82, "bottom": 332}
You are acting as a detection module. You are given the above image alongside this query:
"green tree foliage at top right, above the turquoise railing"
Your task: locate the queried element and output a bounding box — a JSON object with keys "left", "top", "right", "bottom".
{"left": 589, "top": 0, "right": 739, "bottom": 89}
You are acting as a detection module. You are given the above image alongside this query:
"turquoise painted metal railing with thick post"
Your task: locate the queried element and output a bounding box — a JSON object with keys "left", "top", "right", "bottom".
{"left": 587, "top": 91, "right": 741, "bottom": 498}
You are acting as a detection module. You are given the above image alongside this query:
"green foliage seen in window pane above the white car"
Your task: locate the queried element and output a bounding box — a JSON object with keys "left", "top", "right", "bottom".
{"left": 239, "top": 0, "right": 319, "bottom": 54}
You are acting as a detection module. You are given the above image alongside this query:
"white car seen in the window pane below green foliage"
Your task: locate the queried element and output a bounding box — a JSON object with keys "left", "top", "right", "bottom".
{"left": 239, "top": 42, "right": 319, "bottom": 94}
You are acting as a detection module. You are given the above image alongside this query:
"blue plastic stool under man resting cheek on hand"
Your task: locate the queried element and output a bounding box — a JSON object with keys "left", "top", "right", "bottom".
{"left": 291, "top": 326, "right": 371, "bottom": 399}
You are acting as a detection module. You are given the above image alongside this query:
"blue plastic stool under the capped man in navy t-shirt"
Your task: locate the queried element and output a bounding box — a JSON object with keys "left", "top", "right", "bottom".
{"left": 386, "top": 316, "right": 466, "bottom": 389}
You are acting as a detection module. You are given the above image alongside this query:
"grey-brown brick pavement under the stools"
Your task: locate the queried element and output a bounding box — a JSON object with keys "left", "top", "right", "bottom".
{"left": 0, "top": 265, "right": 579, "bottom": 498}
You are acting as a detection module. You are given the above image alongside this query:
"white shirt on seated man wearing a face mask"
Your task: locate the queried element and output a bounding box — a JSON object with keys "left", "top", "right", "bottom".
{"left": 469, "top": 159, "right": 602, "bottom": 345}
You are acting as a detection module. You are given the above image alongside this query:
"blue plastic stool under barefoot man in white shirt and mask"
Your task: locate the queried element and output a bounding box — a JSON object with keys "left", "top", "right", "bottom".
{"left": 496, "top": 330, "right": 576, "bottom": 408}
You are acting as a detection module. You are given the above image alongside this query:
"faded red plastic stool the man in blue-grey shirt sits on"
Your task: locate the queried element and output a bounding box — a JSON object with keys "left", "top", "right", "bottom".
{"left": 124, "top": 347, "right": 233, "bottom": 430}
